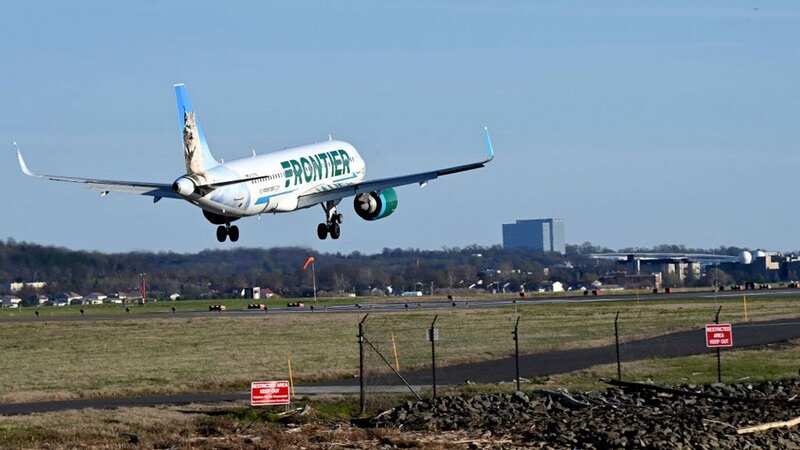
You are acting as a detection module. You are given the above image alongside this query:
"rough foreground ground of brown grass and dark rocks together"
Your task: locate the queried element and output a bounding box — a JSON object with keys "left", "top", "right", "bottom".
{"left": 6, "top": 380, "right": 800, "bottom": 450}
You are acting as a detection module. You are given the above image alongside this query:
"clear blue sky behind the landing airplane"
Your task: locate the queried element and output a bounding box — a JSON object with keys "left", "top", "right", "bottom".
{"left": 0, "top": 1, "right": 800, "bottom": 252}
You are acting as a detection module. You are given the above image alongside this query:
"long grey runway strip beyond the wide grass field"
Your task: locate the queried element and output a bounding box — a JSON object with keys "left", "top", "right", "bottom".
{"left": 0, "top": 289, "right": 800, "bottom": 323}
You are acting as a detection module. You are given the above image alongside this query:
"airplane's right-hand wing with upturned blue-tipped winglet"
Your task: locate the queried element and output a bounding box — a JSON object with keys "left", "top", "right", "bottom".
{"left": 297, "top": 127, "right": 494, "bottom": 208}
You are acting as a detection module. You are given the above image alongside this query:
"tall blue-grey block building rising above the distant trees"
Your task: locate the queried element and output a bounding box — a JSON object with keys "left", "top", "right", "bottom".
{"left": 503, "top": 219, "right": 566, "bottom": 255}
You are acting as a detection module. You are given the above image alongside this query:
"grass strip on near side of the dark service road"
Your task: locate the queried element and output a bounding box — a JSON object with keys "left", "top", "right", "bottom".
{"left": 0, "top": 341, "right": 800, "bottom": 449}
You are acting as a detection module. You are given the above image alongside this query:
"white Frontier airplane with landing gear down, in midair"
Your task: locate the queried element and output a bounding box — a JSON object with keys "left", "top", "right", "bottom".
{"left": 14, "top": 83, "right": 494, "bottom": 242}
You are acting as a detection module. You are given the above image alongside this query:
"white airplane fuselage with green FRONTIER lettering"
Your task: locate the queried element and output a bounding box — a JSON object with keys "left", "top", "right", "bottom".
{"left": 182, "top": 140, "right": 366, "bottom": 217}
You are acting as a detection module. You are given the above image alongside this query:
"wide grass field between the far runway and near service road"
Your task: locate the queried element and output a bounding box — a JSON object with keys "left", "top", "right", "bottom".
{"left": 0, "top": 296, "right": 800, "bottom": 402}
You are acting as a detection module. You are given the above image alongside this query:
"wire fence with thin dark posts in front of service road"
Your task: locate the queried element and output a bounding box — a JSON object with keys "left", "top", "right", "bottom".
{"left": 360, "top": 300, "right": 800, "bottom": 408}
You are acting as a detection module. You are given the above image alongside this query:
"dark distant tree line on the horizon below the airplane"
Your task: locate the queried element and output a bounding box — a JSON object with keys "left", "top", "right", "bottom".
{"left": 0, "top": 239, "right": 752, "bottom": 298}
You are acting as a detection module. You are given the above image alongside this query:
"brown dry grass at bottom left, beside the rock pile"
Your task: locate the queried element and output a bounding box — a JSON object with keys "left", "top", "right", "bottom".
{"left": 0, "top": 405, "right": 472, "bottom": 450}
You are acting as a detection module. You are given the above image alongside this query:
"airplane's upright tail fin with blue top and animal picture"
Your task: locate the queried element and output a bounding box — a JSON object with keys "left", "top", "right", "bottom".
{"left": 175, "top": 83, "right": 219, "bottom": 174}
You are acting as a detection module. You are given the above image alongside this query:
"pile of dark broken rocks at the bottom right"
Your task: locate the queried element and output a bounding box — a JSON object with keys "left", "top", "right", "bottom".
{"left": 370, "top": 380, "right": 800, "bottom": 449}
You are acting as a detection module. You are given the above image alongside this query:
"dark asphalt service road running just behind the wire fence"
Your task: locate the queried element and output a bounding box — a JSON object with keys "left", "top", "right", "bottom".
{"left": 0, "top": 319, "right": 800, "bottom": 415}
